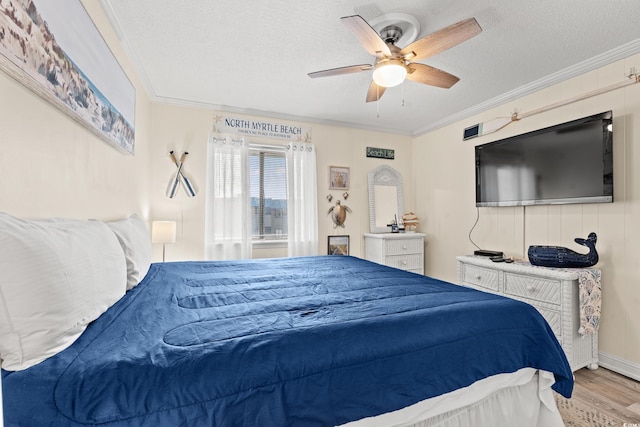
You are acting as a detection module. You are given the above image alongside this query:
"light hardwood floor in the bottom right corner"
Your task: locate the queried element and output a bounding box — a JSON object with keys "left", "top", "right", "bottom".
{"left": 565, "top": 367, "right": 640, "bottom": 427}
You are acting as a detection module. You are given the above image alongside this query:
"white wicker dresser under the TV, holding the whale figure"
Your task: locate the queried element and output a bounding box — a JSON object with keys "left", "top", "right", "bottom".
{"left": 457, "top": 256, "right": 598, "bottom": 371}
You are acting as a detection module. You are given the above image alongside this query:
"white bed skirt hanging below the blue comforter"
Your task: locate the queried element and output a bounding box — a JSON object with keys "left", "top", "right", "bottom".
{"left": 342, "top": 368, "right": 564, "bottom": 427}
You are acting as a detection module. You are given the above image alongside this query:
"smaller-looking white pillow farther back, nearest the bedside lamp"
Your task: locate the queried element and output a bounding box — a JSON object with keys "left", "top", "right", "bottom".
{"left": 106, "top": 214, "right": 151, "bottom": 290}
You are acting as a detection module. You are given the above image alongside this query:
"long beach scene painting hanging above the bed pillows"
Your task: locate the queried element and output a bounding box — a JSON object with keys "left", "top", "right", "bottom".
{"left": 0, "top": 0, "right": 136, "bottom": 154}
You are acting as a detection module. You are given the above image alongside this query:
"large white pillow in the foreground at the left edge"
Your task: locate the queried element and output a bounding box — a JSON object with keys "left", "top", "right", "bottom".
{"left": 0, "top": 212, "right": 127, "bottom": 371}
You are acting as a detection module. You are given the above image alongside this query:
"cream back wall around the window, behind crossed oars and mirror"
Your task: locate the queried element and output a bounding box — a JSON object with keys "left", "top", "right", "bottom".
{"left": 150, "top": 104, "right": 413, "bottom": 261}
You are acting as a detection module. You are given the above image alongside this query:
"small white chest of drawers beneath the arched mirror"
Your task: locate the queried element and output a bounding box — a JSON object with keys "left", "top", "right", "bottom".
{"left": 364, "top": 233, "right": 425, "bottom": 274}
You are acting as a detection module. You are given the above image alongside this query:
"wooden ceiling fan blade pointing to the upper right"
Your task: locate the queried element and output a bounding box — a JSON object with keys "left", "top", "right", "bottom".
{"left": 400, "top": 18, "right": 482, "bottom": 61}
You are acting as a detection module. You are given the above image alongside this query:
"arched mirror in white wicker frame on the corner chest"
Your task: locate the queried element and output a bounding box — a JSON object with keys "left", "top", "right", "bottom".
{"left": 368, "top": 165, "right": 403, "bottom": 233}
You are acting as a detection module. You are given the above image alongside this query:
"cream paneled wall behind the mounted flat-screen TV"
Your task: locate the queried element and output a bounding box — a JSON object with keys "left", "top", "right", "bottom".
{"left": 413, "top": 55, "right": 640, "bottom": 372}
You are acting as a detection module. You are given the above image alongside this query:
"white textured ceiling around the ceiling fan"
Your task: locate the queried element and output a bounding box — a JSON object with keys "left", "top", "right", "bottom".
{"left": 101, "top": 0, "right": 640, "bottom": 135}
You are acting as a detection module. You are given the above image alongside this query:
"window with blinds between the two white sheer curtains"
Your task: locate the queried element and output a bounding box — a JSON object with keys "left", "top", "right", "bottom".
{"left": 249, "top": 145, "right": 288, "bottom": 241}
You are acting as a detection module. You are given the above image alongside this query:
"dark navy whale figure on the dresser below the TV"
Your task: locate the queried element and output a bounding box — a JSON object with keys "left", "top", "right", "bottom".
{"left": 527, "top": 232, "right": 598, "bottom": 268}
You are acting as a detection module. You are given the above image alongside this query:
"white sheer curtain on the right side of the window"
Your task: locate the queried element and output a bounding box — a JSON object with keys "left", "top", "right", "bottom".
{"left": 286, "top": 143, "right": 318, "bottom": 256}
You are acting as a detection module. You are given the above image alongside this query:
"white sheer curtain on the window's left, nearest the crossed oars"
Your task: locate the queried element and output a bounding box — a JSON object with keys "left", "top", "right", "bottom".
{"left": 204, "top": 136, "right": 251, "bottom": 260}
